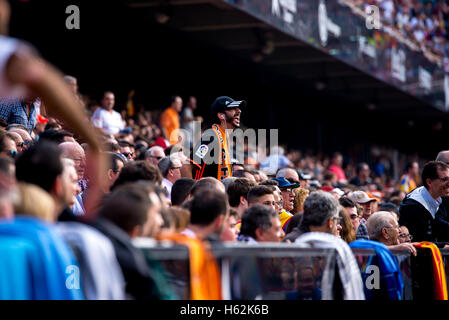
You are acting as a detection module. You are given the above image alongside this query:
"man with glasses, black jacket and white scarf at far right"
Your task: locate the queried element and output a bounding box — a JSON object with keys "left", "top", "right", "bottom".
{"left": 399, "top": 161, "right": 449, "bottom": 247}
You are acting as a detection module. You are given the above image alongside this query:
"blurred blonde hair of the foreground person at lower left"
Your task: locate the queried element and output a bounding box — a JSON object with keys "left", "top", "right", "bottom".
{"left": 14, "top": 182, "right": 55, "bottom": 222}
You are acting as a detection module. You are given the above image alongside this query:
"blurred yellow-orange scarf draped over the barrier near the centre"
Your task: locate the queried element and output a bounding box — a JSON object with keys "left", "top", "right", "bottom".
{"left": 158, "top": 234, "right": 222, "bottom": 300}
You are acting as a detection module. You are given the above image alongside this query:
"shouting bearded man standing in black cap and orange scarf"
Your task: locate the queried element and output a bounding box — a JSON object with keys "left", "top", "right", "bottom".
{"left": 192, "top": 96, "right": 246, "bottom": 181}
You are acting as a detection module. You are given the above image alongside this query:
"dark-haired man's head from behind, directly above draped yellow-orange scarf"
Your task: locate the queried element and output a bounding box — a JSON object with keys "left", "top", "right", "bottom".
{"left": 182, "top": 190, "right": 228, "bottom": 240}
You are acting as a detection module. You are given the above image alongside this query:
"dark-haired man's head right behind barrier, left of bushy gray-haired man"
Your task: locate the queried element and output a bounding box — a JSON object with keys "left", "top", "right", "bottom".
{"left": 237, "top": 204, "right": 285, "bottom": 243}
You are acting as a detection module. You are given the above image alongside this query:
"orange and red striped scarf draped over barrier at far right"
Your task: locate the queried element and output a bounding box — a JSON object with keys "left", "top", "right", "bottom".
{"left": 413, "top": 241, "right": 448, "bottom": 300}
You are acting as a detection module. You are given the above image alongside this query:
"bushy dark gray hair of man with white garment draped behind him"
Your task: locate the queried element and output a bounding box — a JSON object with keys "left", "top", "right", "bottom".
{"left": 302, "top": 191, "right": 340, "bottom": 227}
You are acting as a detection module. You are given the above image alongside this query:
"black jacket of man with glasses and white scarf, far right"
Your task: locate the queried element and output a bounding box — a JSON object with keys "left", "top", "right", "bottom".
{"left": 399, "top": 194, "right": 449, "bottom": 247}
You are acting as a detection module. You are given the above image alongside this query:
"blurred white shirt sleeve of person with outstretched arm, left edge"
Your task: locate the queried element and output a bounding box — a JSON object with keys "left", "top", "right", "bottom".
{"left": 0, "top": 36, "right": 25, "bottom": 101}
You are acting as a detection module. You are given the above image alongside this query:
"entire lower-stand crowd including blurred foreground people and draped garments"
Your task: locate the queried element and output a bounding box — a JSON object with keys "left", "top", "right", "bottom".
{"left": 0, "top": 0, "right": 449, "bottom": 300}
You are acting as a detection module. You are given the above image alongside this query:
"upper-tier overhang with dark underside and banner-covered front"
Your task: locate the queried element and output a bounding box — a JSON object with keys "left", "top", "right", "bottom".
{"left": 126, "top": 0, "right": 448, "bottom": 119}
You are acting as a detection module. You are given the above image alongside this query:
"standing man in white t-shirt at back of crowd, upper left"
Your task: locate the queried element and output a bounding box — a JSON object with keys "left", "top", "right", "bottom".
{"left": 91, "top": 91, "right": 125, "bottom": 134}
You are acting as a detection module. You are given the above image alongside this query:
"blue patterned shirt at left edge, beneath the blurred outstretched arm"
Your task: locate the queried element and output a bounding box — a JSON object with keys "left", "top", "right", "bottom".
{"left": 0, "top": 101, "right": 37, "bottom": 134}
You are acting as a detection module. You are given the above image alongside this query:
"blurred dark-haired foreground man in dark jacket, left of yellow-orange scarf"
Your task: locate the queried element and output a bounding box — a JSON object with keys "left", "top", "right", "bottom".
{"left": 94, "top": 184, "right": 173, "bottom": 300}
